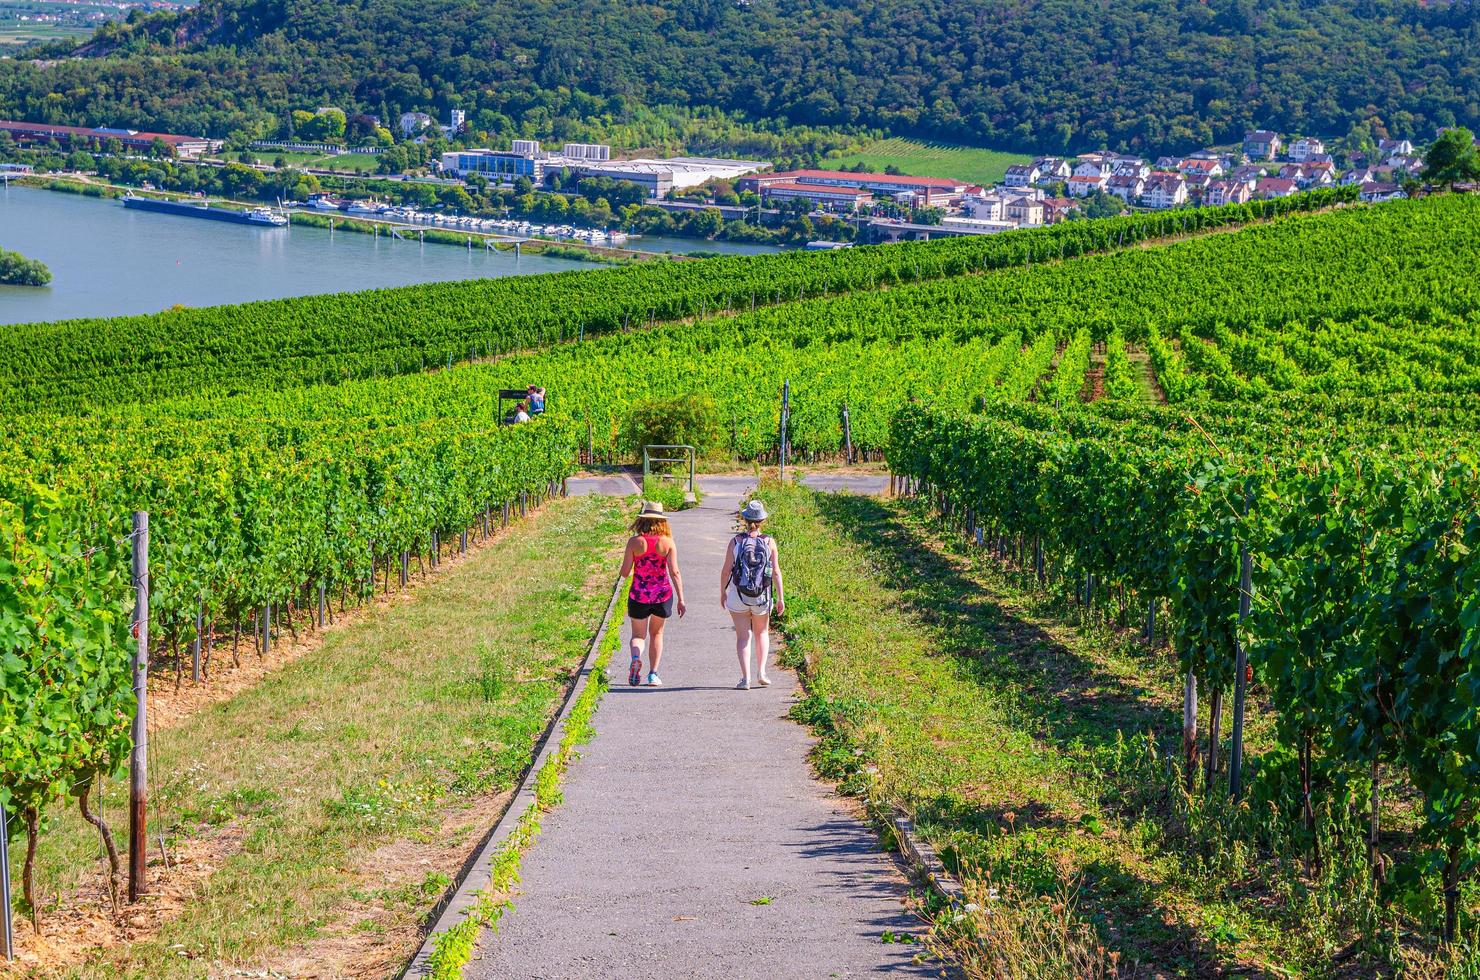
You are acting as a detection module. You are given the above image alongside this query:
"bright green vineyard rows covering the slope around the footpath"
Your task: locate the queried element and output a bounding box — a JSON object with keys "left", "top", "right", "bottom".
{"left": 0, "top": 191, "right": 1480, "bottom": 976}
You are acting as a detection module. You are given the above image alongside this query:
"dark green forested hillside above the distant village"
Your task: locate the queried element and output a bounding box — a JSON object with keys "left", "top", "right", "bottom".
{"left": 0, "top": 0, "right": 1480, "bottom": 151}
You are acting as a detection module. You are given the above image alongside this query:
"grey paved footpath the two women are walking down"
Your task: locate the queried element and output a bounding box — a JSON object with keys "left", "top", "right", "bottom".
{"left": 465, "top": 477, "right": 935, "bottom": 980}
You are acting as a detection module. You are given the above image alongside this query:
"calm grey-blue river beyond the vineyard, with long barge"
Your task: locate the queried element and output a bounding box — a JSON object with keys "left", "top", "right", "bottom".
{"left": 0, "top": 187, "right": 774, "bottom": 324}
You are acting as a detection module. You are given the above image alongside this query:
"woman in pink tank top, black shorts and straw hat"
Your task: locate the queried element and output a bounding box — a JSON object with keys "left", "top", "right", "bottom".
{"left": 622, "top": 502, "right": 684, "bottom": 687}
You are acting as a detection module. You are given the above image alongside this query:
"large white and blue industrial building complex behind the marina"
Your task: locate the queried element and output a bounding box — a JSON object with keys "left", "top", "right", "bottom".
{"left": 443, "top": 139, "right": 771, "bottom": 198}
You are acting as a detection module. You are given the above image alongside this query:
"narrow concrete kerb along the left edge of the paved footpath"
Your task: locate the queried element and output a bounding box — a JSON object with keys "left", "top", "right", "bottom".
{"left": 400, "top": 579, "right": 623, "bottom": 980}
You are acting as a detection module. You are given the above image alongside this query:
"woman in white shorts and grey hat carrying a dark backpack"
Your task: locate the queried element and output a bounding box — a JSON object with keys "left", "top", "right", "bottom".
{"left": 719, "top": 500, "right": 786, "bottom": 691}
